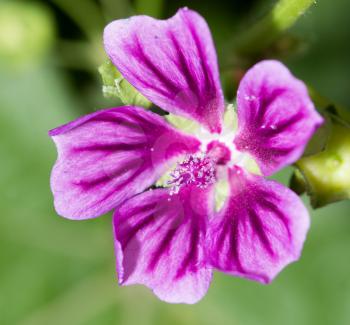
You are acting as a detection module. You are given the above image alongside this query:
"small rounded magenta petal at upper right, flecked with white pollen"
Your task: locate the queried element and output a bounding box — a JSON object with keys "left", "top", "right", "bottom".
{"left": 234, "top": 61, "right": 323, "bottom": 175}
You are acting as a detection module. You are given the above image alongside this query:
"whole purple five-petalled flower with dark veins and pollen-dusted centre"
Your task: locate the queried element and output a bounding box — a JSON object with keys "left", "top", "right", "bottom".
{"left": 50, "top": 9, "right": 322, "bottom": 303}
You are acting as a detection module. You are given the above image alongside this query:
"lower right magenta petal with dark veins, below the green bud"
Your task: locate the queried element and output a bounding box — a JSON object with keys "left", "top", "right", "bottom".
{"left": 207, "top": 167, "right": 309, "bottom": 283}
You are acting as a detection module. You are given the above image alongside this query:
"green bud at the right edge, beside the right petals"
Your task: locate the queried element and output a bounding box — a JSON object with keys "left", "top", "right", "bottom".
{"left": 294, "top": 118, "right": 350, "bottom": 208}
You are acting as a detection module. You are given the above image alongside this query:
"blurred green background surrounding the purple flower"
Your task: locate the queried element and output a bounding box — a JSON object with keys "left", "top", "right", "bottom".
{"left": 0, "top": 0, "right": 350, "bottom": 325}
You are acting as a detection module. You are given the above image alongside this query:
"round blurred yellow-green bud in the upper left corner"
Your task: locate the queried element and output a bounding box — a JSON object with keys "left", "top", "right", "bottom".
{"left": 0, "top": 2, "right": 55, "bottom": 67}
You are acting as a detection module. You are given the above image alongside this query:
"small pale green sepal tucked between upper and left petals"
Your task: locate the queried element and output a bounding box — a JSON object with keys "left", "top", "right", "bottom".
{"left": 98, "top": 60, "right": 152, "bottom": 108}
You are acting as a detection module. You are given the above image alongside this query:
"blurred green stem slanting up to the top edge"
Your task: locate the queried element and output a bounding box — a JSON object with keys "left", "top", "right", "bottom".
{"left": 232, "top": 0, "right": 315, "bottom": 55}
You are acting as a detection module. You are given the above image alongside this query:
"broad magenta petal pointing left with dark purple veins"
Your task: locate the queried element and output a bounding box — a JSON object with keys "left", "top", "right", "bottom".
{"left": 50, "top": 106, "right": 199, "bottom": 219}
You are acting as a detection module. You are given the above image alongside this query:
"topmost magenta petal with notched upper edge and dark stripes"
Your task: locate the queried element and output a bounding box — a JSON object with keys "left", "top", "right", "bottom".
{"left": 104, "top": 9, "right": 224, "bottom": 132}
